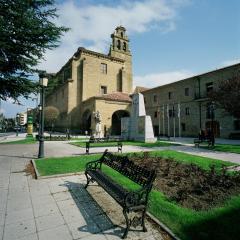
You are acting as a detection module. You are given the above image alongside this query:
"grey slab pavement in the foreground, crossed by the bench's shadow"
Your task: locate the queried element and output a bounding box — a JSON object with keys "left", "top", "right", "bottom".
{"left": 0, "top": 144, "right": 163, "bottom": 240}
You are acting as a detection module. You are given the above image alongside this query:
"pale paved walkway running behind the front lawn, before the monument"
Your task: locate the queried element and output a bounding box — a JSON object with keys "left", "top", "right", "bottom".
{"left": 0, "top": 134, "right": 240, "bottom": 164}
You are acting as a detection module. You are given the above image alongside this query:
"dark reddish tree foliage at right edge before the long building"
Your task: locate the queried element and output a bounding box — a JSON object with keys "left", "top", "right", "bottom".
{"left": 209, "top": 74, "right": 240, "bottom": 119}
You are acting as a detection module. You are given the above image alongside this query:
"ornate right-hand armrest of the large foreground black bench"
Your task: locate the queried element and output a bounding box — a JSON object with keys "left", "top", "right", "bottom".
{"left": 124, "top": 188, "right": 149, "bottom": 207}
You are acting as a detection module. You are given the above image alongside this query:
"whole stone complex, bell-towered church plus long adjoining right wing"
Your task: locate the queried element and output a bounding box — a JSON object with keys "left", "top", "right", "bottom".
{"left": 46, "top": 26, "right": 240, "bottom": 138}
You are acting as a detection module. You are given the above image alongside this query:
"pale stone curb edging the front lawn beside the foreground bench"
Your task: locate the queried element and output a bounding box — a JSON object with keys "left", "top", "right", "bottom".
{"left": 31, "top": 159, "right": 181, "bottom": 240}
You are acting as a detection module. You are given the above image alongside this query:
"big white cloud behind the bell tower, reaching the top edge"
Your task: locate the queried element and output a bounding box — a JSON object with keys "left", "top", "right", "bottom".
{"left": 39, "top": 0, "right": 189, "bottom": 72}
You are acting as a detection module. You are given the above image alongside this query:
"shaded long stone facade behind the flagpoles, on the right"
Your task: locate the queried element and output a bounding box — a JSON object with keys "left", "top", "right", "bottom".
{"left": 142, "top": 64, "right": 240, "bottom": 138}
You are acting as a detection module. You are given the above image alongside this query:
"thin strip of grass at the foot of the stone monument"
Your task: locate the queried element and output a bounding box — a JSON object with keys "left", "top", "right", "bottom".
{"left": 70, "top": 141, "right": 179, "bottom": 147}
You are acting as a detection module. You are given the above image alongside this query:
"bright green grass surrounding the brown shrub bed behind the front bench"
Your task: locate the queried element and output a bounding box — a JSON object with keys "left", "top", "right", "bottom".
{"left": 36, "top": 150, "right": 240, "bottom": 240}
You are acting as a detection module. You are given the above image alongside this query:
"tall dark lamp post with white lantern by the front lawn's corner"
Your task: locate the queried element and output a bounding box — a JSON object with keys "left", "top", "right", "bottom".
{"left": 38, "top": 76, "right": 48, "bottom": 158}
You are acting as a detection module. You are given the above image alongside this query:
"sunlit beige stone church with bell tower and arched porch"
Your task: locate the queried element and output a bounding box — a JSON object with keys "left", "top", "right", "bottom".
{"left": 46, "top": 26, "right": 132, "bottom": 135}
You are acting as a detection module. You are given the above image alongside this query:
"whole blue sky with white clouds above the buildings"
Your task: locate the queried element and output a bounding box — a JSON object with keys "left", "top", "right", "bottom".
{"left": 1, "top": 0, "right": 240, "bottom": 116}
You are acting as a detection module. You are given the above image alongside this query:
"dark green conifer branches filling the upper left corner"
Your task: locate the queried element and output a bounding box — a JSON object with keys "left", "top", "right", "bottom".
{"left": 0, "top": 0, "right": 68, "bottom": 101}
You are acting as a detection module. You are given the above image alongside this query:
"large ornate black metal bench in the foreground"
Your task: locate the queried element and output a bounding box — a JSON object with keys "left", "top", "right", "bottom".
{"left": 85, "top": 149, "right": 156, "bottom": 238}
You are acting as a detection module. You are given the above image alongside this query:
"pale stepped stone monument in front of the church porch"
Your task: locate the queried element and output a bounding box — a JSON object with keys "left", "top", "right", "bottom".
{"left": 121, "top": 93, "right": 157, "bottom": 142}
